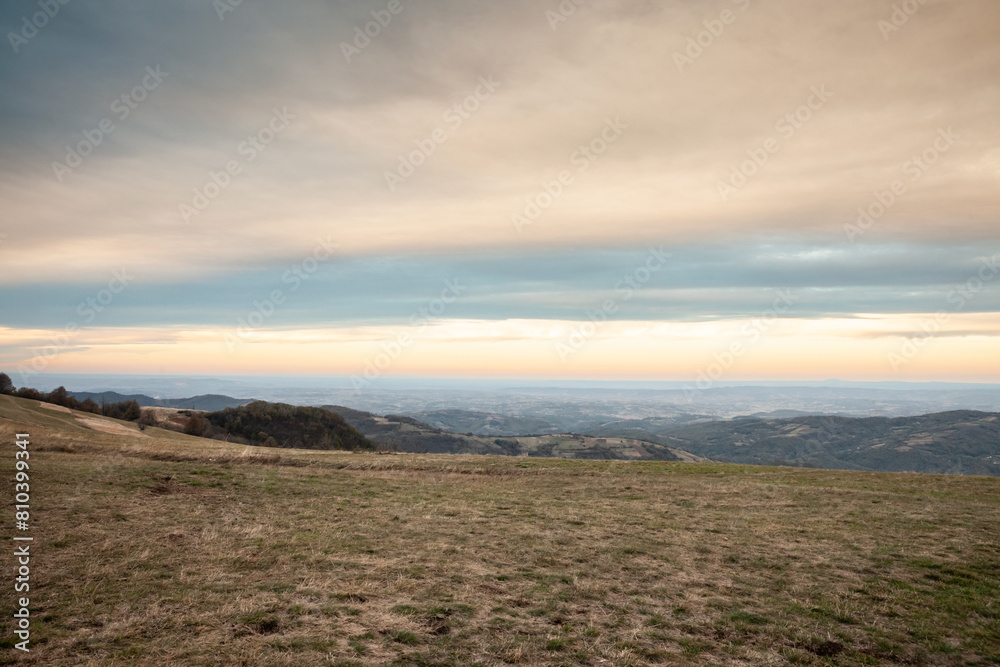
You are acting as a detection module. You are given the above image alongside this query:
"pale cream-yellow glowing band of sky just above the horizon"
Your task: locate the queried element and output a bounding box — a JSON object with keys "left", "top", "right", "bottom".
{"left": 7, "top": 313, "right": 1000, "bottom": 385}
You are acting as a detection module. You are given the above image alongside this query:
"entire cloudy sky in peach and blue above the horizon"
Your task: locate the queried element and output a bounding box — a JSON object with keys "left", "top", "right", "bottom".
{"left": 0, "top": 0, "right": 1000, "bottom": 386}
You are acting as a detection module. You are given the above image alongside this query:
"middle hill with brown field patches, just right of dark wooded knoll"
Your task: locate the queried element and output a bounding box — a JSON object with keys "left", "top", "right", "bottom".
{"left": 323, "top": 405, "right": 701, "bottom": 461}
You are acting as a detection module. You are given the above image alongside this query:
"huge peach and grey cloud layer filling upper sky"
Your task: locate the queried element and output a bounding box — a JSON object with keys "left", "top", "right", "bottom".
{"left": 0, "top": 0, "right": 1000, "bottom": 281}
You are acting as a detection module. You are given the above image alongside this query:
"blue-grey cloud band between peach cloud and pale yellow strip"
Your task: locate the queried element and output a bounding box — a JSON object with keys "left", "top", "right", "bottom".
{"left": 0, "top": 239, "right": 1000, "bottom": 329}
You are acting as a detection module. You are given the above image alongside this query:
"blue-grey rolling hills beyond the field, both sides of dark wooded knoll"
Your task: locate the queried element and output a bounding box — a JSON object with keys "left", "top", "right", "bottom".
{"left": 58, "top": 392, "right": 1000, "bottom": 476}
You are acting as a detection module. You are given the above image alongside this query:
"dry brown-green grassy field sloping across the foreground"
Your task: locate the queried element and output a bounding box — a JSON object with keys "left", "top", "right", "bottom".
{"left": 0, "top": 397, "right": 1000, "bottom": 666}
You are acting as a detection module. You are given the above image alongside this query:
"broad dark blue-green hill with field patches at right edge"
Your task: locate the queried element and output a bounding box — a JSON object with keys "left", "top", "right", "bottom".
{"left": 656, "top": 411, "right": 1000, "bottom": 476}
